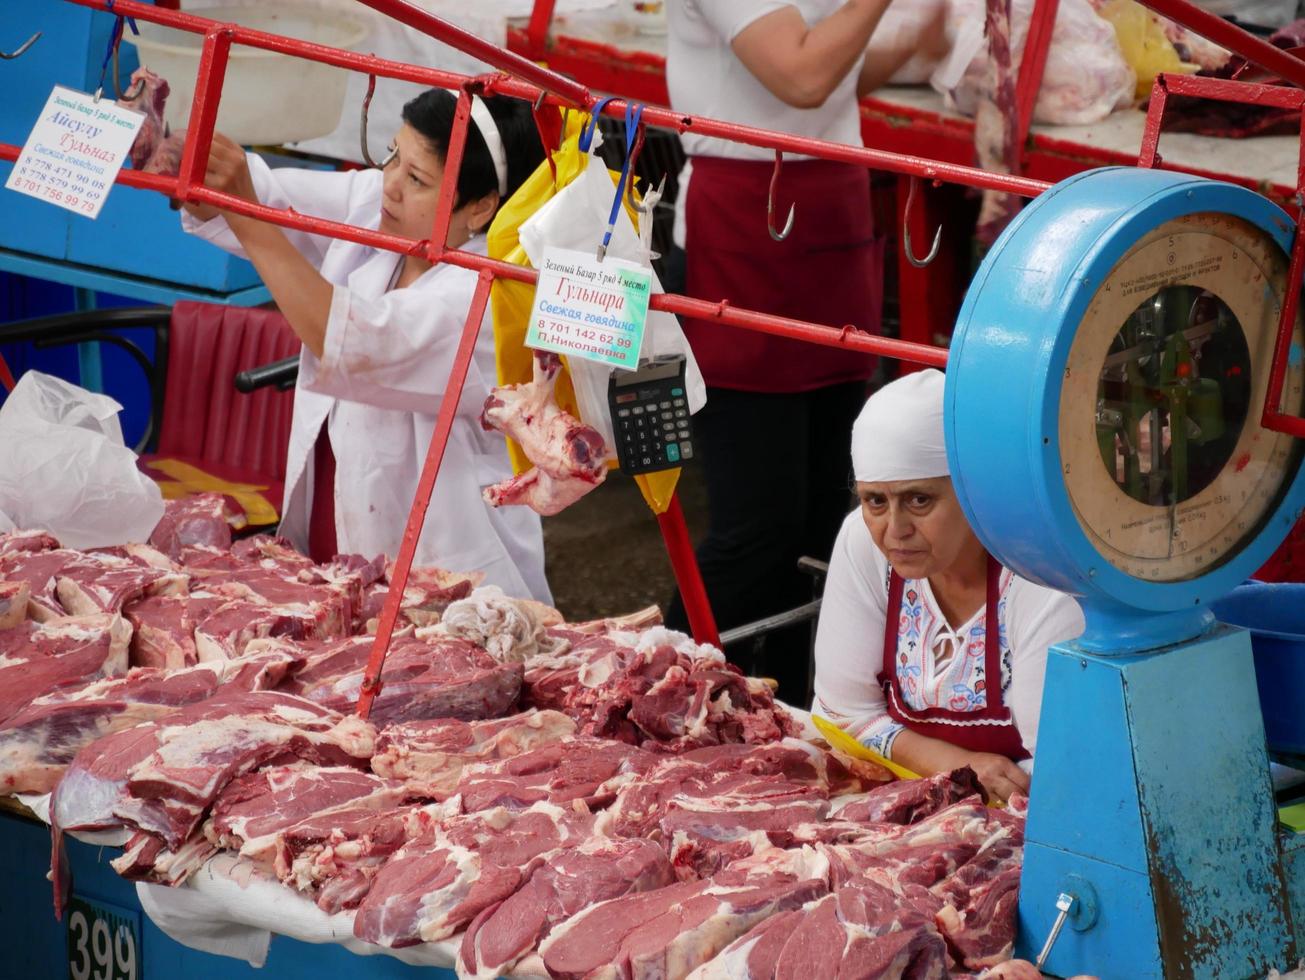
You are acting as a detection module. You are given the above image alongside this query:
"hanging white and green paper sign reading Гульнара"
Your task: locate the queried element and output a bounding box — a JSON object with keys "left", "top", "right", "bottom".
{"left": 526, "top": 248, "right": 653, "bottom": 371}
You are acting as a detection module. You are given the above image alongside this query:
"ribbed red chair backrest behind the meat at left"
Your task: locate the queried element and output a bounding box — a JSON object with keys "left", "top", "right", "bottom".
{"left": 141, "top": 301, "right": 300, "bottom": 524}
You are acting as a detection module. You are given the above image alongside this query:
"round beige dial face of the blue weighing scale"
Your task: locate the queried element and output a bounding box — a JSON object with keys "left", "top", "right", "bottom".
{"left": 1058, "top": 213, "right": 1305, "bottom": 582}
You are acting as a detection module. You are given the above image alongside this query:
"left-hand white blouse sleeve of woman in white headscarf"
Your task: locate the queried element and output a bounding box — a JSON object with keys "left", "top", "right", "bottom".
{"left": 812, "top": 510, "right": 902, "bottom": 758}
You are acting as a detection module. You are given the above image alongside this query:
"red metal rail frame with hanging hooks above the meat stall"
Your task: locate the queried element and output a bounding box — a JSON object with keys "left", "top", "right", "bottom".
{"left": 23, "top": 0, "right": 1305, "bottom": 718}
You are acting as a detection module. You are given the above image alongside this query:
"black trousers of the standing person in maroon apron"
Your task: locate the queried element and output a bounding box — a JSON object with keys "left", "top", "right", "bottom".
{"left": 667, "top": 381, "right": 867, "bottom": 705}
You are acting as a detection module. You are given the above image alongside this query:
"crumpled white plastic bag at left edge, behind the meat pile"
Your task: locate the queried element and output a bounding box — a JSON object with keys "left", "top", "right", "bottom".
{"left": 0, "top": 371, "right": 163, "bottom": 548}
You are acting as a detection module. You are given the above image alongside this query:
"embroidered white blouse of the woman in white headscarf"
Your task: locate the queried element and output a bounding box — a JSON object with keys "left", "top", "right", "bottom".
{"left": 812, "top": 510, "right": 1083, "bottom": 758}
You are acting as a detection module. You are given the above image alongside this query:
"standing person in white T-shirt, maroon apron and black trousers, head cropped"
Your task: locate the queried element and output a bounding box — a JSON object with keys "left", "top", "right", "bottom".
{"left": 667, "top": 0, "right": 942, "bottom": 701}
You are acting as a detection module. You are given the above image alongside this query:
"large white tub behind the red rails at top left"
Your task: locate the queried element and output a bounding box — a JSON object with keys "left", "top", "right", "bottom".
{"left": 125, "top": 3, "right": 367, "bottom": 145}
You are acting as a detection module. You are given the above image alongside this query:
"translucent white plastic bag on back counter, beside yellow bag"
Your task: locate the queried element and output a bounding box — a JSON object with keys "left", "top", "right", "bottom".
{"left": 933, "top": 0, "right": 1137, "bottom": 125}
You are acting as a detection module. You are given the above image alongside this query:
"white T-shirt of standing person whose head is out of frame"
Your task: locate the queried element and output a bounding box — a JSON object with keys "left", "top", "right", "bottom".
{"left": 666, "top": 0, "right": 861, "bottom": 159}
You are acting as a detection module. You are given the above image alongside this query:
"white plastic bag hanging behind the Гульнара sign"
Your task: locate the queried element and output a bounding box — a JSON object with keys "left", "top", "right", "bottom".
{"left": 521, "top": 133, "right": 707, "bottom": 446}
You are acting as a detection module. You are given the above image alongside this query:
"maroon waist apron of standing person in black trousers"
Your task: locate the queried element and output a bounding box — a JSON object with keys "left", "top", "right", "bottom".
{"left": 683, "top": 157, "right": 883, "bottom": 394}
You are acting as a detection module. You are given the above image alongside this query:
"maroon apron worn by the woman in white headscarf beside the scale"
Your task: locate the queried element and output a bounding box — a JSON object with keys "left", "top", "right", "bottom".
{"left": 878, "top": 556, "right": 1028, "bottom": 762}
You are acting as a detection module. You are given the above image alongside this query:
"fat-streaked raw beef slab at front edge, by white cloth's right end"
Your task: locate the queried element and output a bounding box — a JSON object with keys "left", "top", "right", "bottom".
{"left": 354, "top": 803, "right": 592, "bottom": 946}
